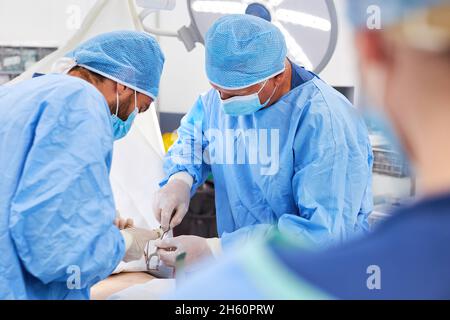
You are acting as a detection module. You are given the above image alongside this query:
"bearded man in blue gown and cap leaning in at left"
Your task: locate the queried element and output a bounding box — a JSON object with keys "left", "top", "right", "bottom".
{"left": 0, "top": 31, "right": 164, "bottom": 299}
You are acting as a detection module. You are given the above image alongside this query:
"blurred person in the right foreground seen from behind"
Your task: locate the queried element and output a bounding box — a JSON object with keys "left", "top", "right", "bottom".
{"left": 170, "top": 0, "right": 450, "bottom": 299}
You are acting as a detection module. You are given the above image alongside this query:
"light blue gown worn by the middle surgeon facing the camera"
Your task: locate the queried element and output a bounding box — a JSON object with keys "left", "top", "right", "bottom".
{"left": 161, "top": 65, "right": 373, "bottom": 248}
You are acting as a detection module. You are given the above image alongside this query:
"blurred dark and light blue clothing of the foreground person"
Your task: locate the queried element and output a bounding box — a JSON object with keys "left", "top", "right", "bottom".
{"left": 171, "top": 194, "right": 450, "bottom": 300}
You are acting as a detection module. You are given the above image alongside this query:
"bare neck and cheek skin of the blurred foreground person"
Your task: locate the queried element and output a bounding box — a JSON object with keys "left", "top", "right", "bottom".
{"left": 385, "top": 43, "right": 450, "bottom": 197}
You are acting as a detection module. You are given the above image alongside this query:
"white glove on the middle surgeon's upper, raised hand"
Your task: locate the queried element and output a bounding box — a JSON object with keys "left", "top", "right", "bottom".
{"left": 153, "top": 172, "right": 193, "bottom": 231}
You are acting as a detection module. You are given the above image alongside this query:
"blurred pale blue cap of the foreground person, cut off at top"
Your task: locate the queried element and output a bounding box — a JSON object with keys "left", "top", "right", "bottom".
{"left": 347, "top": 0, "right": 449, "bottom": 28}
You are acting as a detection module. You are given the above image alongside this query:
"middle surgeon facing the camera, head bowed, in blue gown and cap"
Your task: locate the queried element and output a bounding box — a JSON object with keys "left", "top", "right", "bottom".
{"left": 154, "top": 15, "right": 372, "bottom": 266}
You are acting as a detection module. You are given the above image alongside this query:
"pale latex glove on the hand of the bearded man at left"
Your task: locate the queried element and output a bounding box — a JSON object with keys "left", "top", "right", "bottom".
{"left": 120, "top": 228, "right": 160, "bottom": 262}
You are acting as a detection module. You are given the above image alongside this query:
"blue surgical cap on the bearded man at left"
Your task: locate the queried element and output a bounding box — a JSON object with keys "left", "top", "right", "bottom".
{"left": 66, "top": 31, "right": 164, "bottom": 99}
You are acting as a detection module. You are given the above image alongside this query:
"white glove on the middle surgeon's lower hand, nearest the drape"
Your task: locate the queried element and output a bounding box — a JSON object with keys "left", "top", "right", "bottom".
{"left": 155, "top": 236, "right": 222, "bottom": 268}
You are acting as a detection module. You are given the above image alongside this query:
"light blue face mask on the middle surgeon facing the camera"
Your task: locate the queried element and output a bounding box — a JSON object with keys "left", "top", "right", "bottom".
{"left": 219, "top": 80, "right": 278, "bottom": 116}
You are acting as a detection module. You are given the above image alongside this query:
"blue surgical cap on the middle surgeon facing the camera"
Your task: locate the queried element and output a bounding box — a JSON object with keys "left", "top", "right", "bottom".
{"left": 205, "top": 14, "right": 287, "bottom": 90}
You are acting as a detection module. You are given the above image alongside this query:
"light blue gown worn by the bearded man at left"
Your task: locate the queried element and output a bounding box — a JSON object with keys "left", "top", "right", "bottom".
{"left": 0, "top": 75, "right": 125, "bottom": 299}
